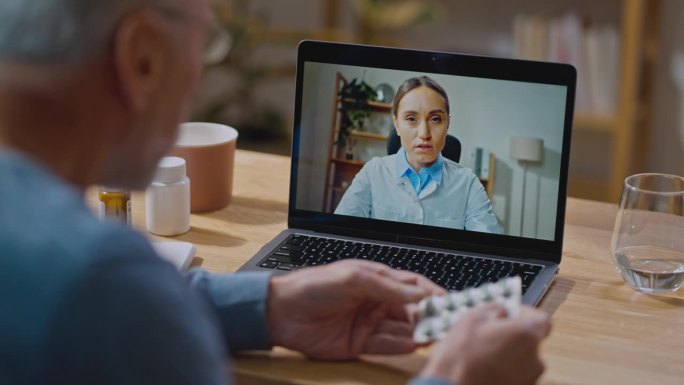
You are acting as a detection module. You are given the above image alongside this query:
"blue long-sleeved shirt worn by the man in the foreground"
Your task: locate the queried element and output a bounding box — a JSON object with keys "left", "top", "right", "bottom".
{"left": 0, "top": 151, "right": 448, "bottom": 385}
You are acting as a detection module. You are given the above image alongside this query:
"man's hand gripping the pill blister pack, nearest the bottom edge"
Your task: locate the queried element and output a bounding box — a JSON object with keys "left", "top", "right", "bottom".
{"left": 420, "top": 305, "right": 551, "bottom": 385}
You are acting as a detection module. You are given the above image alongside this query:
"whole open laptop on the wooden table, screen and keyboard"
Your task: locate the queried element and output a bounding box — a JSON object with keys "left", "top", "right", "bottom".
{"left": 240, "top": 41, "right": 576, "bottom": 304}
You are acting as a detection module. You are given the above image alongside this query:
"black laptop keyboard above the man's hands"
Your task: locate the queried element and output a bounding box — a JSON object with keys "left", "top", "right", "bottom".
{"left": 258, "top": 234, "right": 543, "bottom": 294}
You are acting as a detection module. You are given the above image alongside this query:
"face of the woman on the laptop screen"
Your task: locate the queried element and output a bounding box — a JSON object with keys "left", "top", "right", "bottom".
{"left": 393, "top": 86, "right": 449, "bottom": 171}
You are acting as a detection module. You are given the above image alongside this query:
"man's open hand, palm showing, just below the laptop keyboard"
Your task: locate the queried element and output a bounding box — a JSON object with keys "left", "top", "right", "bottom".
{"left": 267, "top": 260, "right": 446, "bottom": 360}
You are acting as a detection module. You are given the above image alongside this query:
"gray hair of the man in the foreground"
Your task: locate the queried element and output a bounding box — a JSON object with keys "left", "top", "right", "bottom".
{"left": 0, "top": 0, "right": 178, "bottom": 63}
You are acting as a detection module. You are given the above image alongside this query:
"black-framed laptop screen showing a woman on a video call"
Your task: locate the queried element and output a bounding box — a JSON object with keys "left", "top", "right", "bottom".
{"left": 291, "top": 42, "right": 574, "bottom": 258}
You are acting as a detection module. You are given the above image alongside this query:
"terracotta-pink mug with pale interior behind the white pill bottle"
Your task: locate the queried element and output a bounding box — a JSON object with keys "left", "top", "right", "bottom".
{"left": 170, "top": 123, "right": 238, "bottom": 213}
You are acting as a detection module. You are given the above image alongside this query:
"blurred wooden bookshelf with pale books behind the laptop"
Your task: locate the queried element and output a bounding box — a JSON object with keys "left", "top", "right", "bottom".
{"left": 422, "top": 0, "right": 661, "bottom": 202}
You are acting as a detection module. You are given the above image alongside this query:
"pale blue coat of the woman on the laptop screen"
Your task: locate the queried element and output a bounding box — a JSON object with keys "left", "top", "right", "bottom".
{"left": 335, "top": 152, "right": 501, "bottom": 234}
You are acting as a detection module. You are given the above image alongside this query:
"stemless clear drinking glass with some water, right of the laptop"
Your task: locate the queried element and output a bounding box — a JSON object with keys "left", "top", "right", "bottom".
{"left": 611, "top": 174, "right": 684, "bottom": 294}
